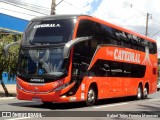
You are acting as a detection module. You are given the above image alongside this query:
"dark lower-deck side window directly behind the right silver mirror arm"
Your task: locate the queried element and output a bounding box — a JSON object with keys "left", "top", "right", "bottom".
{"left": 72, "top": 41, "right": 93, "bottom": 79}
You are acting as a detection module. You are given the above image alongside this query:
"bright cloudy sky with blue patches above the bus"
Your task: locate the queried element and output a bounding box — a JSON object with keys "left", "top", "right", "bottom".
{"left": 0, "top": 0, "right": 160, "bottom": 57}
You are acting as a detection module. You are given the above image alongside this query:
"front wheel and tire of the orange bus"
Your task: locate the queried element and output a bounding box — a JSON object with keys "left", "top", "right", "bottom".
{"left": 86, "top": 86, "right": 97, "bottom": 106}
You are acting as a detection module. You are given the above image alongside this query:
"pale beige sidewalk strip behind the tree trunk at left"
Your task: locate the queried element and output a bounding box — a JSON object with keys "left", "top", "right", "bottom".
{"left": 0, "top": 84, "right": 16, "bottom": 94}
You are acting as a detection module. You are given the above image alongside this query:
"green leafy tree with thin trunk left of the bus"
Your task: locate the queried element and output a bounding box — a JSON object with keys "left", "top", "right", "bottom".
{"left": 0, "top": 34, "right": 21, "bottom": 96}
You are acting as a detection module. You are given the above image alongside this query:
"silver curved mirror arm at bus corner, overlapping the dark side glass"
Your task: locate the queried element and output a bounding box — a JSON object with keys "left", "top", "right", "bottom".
{"left": 63, "top": 36, "right": 92, "bottom": 58}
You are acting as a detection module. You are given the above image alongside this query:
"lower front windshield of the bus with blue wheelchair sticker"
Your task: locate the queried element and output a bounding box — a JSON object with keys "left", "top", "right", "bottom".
{"left": 19, "top": 47, "right": 67, "bottom": 78}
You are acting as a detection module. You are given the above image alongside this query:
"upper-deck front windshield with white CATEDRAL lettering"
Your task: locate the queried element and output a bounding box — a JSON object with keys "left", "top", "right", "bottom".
{"left": 22, "top": 19, "right": 74, "bottom": 45}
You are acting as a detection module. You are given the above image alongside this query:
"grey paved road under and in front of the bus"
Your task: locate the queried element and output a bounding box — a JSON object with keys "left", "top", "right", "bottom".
{"left": 0, "top": 92, "right": 160, "bottom": 120}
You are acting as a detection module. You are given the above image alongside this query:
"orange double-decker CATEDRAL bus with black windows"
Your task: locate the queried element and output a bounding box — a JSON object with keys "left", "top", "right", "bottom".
{"left": 11, "top": 15, "right": 158, "bottom": 105}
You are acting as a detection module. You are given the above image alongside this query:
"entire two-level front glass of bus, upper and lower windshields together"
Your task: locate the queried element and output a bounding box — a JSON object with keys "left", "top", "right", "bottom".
{"left": 18, "top": 19, "right": 74, "bottom": 82}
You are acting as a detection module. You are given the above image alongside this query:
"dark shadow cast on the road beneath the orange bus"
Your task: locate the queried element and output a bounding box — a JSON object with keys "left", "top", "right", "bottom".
{"left": 9, "top": 97, "right": 152, "bottom": 110}
